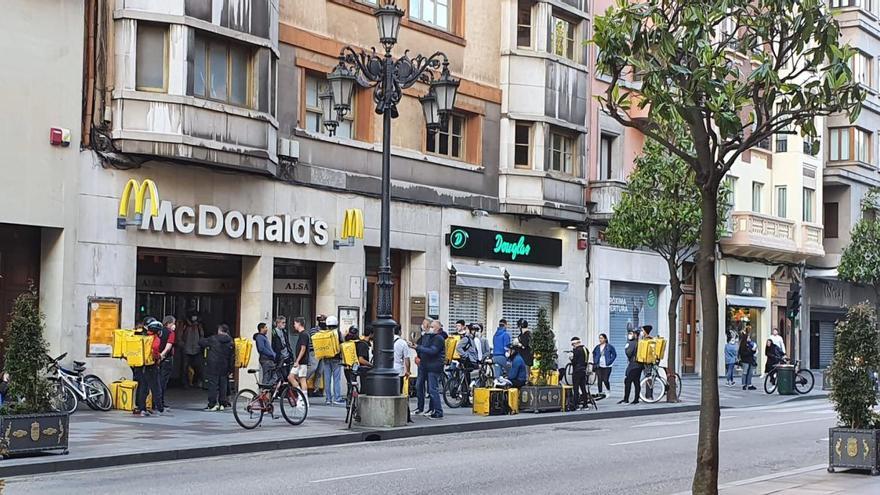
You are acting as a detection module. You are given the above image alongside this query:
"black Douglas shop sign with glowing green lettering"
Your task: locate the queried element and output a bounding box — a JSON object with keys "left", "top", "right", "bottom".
{"left": 446, "top": 225, "right": 562, "bottom": 266}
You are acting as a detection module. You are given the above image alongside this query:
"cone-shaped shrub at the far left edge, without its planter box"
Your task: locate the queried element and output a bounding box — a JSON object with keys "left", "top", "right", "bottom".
{"left": 3, "top": 291, "right": 51, "bottom": 414}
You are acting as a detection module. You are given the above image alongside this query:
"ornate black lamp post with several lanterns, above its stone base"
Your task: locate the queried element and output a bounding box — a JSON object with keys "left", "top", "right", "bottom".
{"left": 322, "top": 0, "right": 459, "bottom": 397}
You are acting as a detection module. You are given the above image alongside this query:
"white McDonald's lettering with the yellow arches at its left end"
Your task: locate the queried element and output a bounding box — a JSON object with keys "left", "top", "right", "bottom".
{"left": 117, "top": 181, "right": 330, "bottom": 246}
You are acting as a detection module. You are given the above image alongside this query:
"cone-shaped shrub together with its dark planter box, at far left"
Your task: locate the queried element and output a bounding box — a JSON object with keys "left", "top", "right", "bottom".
{"left": 0, "top": 291, "right": 69, "bottom": 457}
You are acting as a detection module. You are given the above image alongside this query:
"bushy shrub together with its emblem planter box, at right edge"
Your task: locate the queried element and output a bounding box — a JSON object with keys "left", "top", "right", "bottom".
{"left": 828, "top": 303, "right": 880, "bottom": 475}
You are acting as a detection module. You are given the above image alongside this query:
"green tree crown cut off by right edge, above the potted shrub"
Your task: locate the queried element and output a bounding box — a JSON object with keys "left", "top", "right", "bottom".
{"left": 837, "top": 188, "right": 880, "bottom": 312}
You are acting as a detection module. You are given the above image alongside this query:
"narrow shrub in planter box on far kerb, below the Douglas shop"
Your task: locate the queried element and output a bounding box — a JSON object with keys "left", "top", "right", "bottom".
{"left": 519, "top": 308, "right": 562, "bottom": 412}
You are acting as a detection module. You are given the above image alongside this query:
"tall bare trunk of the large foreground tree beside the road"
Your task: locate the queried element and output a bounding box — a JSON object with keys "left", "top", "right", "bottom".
{"left": 692, "top": 186, "right": 721, "bottom": 495}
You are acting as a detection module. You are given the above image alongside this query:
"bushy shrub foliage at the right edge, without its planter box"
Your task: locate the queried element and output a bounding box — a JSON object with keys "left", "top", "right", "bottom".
{"left": 830, "top": 303, "right": 880, "bottom": 429}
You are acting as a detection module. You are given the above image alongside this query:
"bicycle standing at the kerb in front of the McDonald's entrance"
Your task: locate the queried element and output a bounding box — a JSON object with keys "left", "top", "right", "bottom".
{"left": 232, "top": 367, "right": 309, "bottom": 430}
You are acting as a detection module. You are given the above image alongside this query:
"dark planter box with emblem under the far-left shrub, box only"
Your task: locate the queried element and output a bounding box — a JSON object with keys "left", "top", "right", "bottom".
{"left": 0, "top": 413, "right": 70, "bottom": 458}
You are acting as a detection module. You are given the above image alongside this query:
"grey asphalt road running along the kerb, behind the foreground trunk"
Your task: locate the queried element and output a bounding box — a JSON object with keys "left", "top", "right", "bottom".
{"left": 3, "top": 400, "right": 835, "bottom": 495}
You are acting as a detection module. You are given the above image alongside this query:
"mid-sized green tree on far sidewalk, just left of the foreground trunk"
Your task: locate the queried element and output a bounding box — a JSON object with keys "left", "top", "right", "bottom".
{"left": 605, "top": 139, "right": 725, "bottom": 402}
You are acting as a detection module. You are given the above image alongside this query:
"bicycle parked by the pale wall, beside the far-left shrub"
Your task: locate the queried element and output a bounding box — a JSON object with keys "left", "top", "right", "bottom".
{"left": 47, "top": 352, "right": 113, "bottom": 414}
